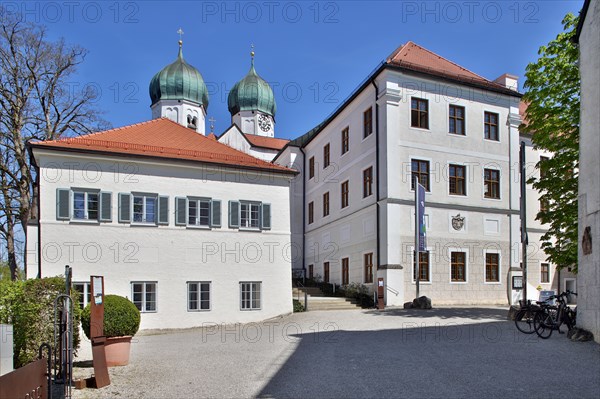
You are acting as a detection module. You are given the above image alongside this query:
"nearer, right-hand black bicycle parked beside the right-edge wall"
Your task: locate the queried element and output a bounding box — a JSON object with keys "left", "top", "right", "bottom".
{"left": 533, "top": 291, "right": 577, "bottom": 339}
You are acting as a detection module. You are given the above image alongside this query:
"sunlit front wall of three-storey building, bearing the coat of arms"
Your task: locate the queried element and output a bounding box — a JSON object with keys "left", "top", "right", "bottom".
{"left": 379, "top": 71, "right": 519, "bottom": 304}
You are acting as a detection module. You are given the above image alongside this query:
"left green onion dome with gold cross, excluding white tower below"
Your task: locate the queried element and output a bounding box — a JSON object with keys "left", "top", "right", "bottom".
{"left": 149, "top": 41, "right": 208, "bottom": 110}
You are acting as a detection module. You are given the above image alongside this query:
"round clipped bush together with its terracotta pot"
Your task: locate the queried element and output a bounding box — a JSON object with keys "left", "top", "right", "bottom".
{"left": 81, "top": 295, "right": 140, "bottom": 367}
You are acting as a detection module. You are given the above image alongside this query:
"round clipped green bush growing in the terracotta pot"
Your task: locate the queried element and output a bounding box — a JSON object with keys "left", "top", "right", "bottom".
{"left": 81, "top": 295, "right": 140, "bottom": 338}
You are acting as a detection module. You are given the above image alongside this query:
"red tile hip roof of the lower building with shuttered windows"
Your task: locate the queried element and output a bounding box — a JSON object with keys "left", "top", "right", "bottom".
{"left": 31, "top": 118, "right": 296, "bottom": 173}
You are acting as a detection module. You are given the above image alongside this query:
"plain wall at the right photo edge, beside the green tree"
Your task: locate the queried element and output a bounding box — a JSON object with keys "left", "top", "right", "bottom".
{"left": 577, "top": 1, "right": 600, "bottom": 342}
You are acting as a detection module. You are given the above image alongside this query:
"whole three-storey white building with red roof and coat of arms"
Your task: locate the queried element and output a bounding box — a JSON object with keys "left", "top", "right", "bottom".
{"left": 275, "top": 42, "right": 553, "bottom": 306}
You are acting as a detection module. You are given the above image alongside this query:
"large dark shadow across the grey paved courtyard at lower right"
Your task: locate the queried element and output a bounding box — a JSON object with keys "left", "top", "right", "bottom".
{"left": 259, "top": 322, "right": 600, "bottom": 398}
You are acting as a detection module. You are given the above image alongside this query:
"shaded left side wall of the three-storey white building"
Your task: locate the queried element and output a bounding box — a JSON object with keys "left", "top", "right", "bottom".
{"left": 304, "top": 87, "right": 377, "bottom": 294}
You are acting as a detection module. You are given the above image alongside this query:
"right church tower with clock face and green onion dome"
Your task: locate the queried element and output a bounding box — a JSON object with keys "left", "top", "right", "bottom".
{"left": 227, "top": 51, "right": 276, "bottom": 137}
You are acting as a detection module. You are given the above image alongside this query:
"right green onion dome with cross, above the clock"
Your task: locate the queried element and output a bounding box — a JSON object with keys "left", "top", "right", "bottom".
{"left": 227, "top": 53, "right": 277, "bottom": 118}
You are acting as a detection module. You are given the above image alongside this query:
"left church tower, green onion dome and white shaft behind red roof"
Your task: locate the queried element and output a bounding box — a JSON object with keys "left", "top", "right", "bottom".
{"left": 149, "top": 38, "right": 208, "bottom": 134}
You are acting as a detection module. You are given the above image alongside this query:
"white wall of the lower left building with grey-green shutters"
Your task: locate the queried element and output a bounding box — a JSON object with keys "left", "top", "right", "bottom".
{"left": 28, "top": 150, "right": 292, "bottom": 329}
